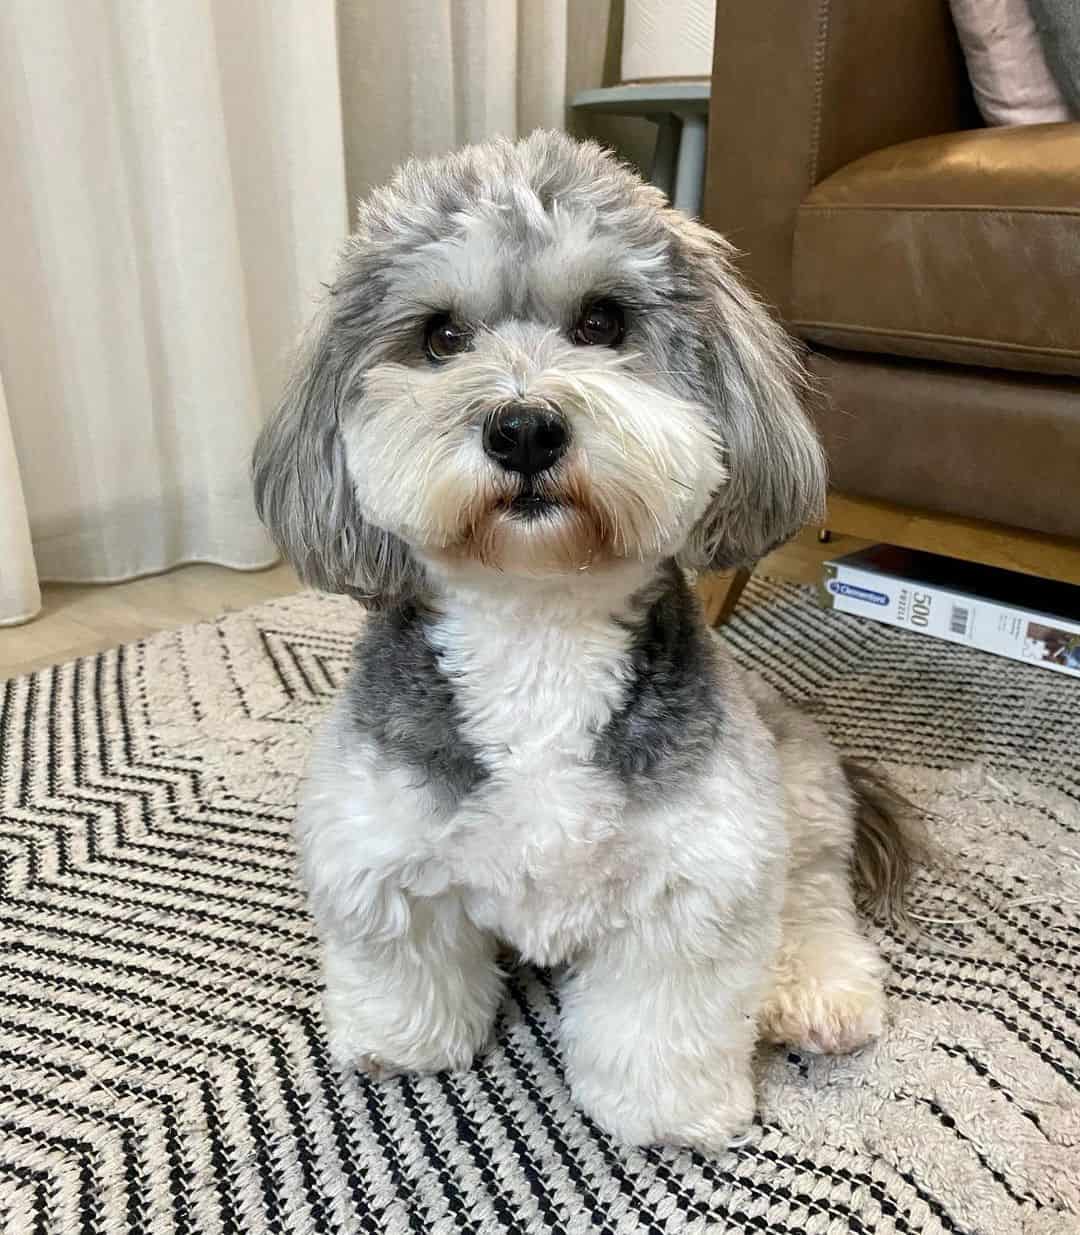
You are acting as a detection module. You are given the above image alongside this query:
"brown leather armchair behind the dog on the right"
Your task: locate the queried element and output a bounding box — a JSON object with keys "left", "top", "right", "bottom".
{"left": 704, "top": 0, "right": 1080, "bottom": 595}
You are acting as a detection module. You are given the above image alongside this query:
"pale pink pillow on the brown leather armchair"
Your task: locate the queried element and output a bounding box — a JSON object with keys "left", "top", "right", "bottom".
{"left": 949, "top": 0, "right": 1069, "bottom": 125}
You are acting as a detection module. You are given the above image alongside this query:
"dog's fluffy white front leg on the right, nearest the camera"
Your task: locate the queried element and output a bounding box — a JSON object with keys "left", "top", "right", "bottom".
{"left": 562, "top": 893, "right": 776, "bottom": 1152}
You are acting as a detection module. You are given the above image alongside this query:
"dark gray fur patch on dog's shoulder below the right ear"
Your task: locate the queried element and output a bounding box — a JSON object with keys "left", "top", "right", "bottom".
{"left": 592, "top": 562, "right": 724, "bottom": 797}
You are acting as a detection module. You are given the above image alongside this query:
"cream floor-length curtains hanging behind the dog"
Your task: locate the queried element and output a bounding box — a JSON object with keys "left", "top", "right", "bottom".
{"left": 0, "top": 0, "right": 648, "bottom": 624}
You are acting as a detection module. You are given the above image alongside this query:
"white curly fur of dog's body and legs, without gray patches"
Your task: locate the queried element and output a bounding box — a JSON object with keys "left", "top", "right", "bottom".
{"left": 297, "top": 572, "right": 884, "bottom": 1151}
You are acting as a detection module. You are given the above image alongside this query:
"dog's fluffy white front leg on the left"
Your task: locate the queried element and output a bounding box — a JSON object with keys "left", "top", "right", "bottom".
{"left": 321, "top": 892, "right": 502, "bottom": 1076}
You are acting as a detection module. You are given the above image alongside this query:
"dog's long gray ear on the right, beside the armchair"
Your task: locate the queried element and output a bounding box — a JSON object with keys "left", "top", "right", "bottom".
{"left": 680, "top": 221, "right": 825, "bottom": 571}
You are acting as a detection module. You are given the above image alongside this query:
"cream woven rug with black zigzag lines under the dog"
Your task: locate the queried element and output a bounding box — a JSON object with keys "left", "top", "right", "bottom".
{"left": 0, "top": 580, "right": 1080, "bottom": 1235}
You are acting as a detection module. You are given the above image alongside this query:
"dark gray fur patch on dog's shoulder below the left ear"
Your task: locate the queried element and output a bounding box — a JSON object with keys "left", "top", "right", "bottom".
{"left": 346, "top": 605, "right": 488, "bottom": 805}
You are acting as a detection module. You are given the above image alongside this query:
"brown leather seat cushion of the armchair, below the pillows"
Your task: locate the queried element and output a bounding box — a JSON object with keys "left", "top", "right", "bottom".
{"left": 790, "top": 124, "right": 1080, "bottom": 374}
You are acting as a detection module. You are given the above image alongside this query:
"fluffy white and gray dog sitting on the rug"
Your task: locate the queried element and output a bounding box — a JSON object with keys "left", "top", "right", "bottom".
{"left": 255, "top": 132, "right": 903, "bottom": 1151}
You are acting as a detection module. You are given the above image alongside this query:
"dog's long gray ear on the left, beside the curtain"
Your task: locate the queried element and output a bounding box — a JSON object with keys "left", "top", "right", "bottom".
{"left": 252, "top": 289, "right": 423, "bottom": 608}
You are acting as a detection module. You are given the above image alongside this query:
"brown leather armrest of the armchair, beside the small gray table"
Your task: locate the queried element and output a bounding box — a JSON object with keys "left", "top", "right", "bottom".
{"left": 704, "top": 0, "right": 979, "bottom": 316}
